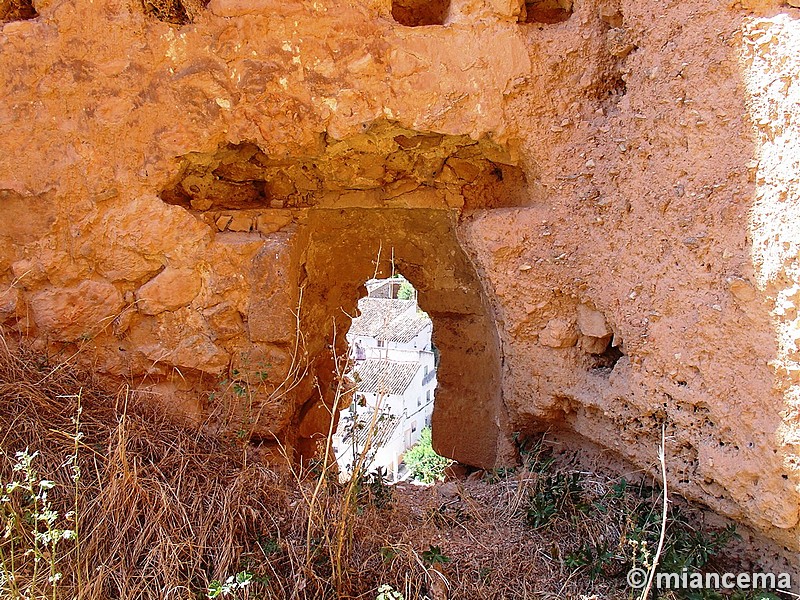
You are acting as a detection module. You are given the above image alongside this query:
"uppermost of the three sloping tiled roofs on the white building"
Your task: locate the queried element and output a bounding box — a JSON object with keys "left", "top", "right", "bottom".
{"left": 348, "top": 297, "right": 430, "bottom": 342}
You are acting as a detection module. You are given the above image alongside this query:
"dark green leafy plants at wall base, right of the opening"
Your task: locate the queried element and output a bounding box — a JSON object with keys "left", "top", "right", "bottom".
{"left": 506, "top": 438, "right": 744, "bottom": 599}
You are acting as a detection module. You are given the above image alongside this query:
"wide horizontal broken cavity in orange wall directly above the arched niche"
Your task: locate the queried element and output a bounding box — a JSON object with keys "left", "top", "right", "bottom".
{"left": 161, "top": 123, "right": 528, "bottom": 227}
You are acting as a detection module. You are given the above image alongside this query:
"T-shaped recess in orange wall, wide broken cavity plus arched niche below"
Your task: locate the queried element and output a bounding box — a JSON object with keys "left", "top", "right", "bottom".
{"left": 161, "top": 122, "right": 531, "bottom": 468}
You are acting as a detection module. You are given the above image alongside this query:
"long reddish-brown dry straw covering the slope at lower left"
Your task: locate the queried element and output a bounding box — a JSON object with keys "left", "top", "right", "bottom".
{"left": 0, "top": 332, "right": 446, "bottom": 600}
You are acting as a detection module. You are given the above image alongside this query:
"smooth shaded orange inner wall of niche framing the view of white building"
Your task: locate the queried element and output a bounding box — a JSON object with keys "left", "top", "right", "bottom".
{"left": 298, "top": 209, "right": 513, "bottom": 467}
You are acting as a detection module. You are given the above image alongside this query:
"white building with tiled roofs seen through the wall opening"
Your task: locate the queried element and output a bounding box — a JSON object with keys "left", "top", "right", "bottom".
{"left": 333, "top": 277, "right": 436, "bottom": 480}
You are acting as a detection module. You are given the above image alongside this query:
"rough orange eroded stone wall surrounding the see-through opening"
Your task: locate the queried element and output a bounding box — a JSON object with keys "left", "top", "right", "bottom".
{"left": 0, "top": 0, "right": 800, "bottom": 549}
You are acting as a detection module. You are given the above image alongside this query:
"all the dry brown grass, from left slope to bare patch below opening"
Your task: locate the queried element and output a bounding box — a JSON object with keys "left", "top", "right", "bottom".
{"left": 0, "top": 338, "right": 644, "bottom": 600}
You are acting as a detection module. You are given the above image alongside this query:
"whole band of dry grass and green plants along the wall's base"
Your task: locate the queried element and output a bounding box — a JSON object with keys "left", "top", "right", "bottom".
{"left": 0, "top": 344, "right": 780, "bottom": 600}
